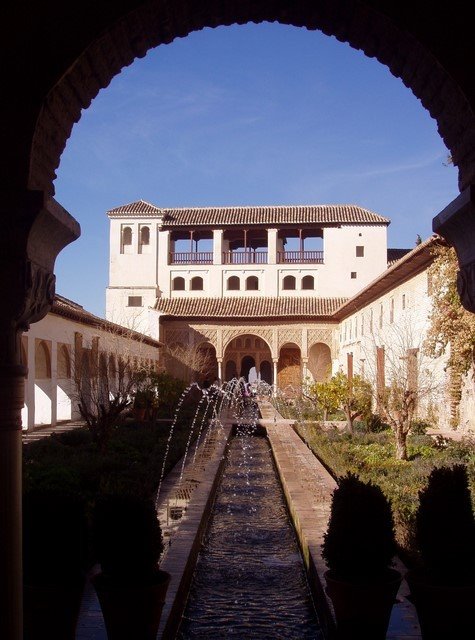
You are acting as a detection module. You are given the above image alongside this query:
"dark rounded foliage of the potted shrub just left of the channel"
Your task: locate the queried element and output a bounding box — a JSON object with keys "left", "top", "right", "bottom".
{"left": 92, "top": 494, "right": 163, "bottom": 582}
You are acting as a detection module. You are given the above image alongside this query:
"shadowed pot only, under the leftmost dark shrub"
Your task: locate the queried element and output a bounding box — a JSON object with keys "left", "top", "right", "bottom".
{"left": 23, "top": 578, "right": 85, "bottom": 640}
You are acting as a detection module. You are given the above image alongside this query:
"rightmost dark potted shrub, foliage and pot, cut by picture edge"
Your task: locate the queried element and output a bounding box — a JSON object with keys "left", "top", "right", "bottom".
{"left": 406, "top": 464, "right": 475, "bottom": 639}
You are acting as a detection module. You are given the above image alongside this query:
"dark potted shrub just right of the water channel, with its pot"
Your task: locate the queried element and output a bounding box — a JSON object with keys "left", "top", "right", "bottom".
{"left": 322, "top": 473, "right": 402, "bottom": 640}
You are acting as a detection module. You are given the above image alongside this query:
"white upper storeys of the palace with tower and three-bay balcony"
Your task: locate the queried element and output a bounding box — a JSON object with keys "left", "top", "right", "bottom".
{"left": 106, "top": 201, "right": 389, "bottom": 332}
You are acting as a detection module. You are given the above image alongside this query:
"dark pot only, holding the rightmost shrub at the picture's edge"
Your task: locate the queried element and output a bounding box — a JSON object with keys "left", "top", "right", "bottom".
{"left": 406, "top": 570, "right": 475, "bottom": 640}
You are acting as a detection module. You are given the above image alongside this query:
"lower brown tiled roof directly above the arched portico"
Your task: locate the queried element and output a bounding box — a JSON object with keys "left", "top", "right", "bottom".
{"left": 155, "top": 296, "right": 346, "bottom": 320}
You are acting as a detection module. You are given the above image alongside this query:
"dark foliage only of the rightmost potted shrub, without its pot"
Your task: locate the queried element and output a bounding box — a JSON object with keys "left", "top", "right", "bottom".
{"left": 416, "top": 465, "right": 475, "bottom": 584}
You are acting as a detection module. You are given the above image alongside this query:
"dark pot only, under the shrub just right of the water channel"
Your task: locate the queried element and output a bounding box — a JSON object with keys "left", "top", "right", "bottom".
{"left": 325, "top": 569, "right": 402, "bottom": 640}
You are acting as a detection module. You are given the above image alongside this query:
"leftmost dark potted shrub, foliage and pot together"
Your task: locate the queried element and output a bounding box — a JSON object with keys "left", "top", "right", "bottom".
{"left": 23, "top": 489, "right": 88, "bottom": 640}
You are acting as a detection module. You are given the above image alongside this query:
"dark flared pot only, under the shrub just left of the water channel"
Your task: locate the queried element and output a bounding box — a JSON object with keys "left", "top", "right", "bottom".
{"left": 92, "top": 571, "right": 171, "bottom": 640}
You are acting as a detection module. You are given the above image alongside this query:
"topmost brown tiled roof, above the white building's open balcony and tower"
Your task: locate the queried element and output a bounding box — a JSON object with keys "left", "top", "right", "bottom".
{"left": 108, "top": 200, "right": 390, "bottom": 228}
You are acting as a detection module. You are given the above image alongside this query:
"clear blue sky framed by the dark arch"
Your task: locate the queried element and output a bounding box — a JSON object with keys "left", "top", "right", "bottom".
{"left": 55, "top": 24, "right": 458, "bottom": 315}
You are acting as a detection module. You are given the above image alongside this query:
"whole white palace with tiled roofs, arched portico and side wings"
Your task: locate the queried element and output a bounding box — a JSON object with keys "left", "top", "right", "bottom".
{"left": 23, "top": 200, "right": 475, "bottom": 430}
